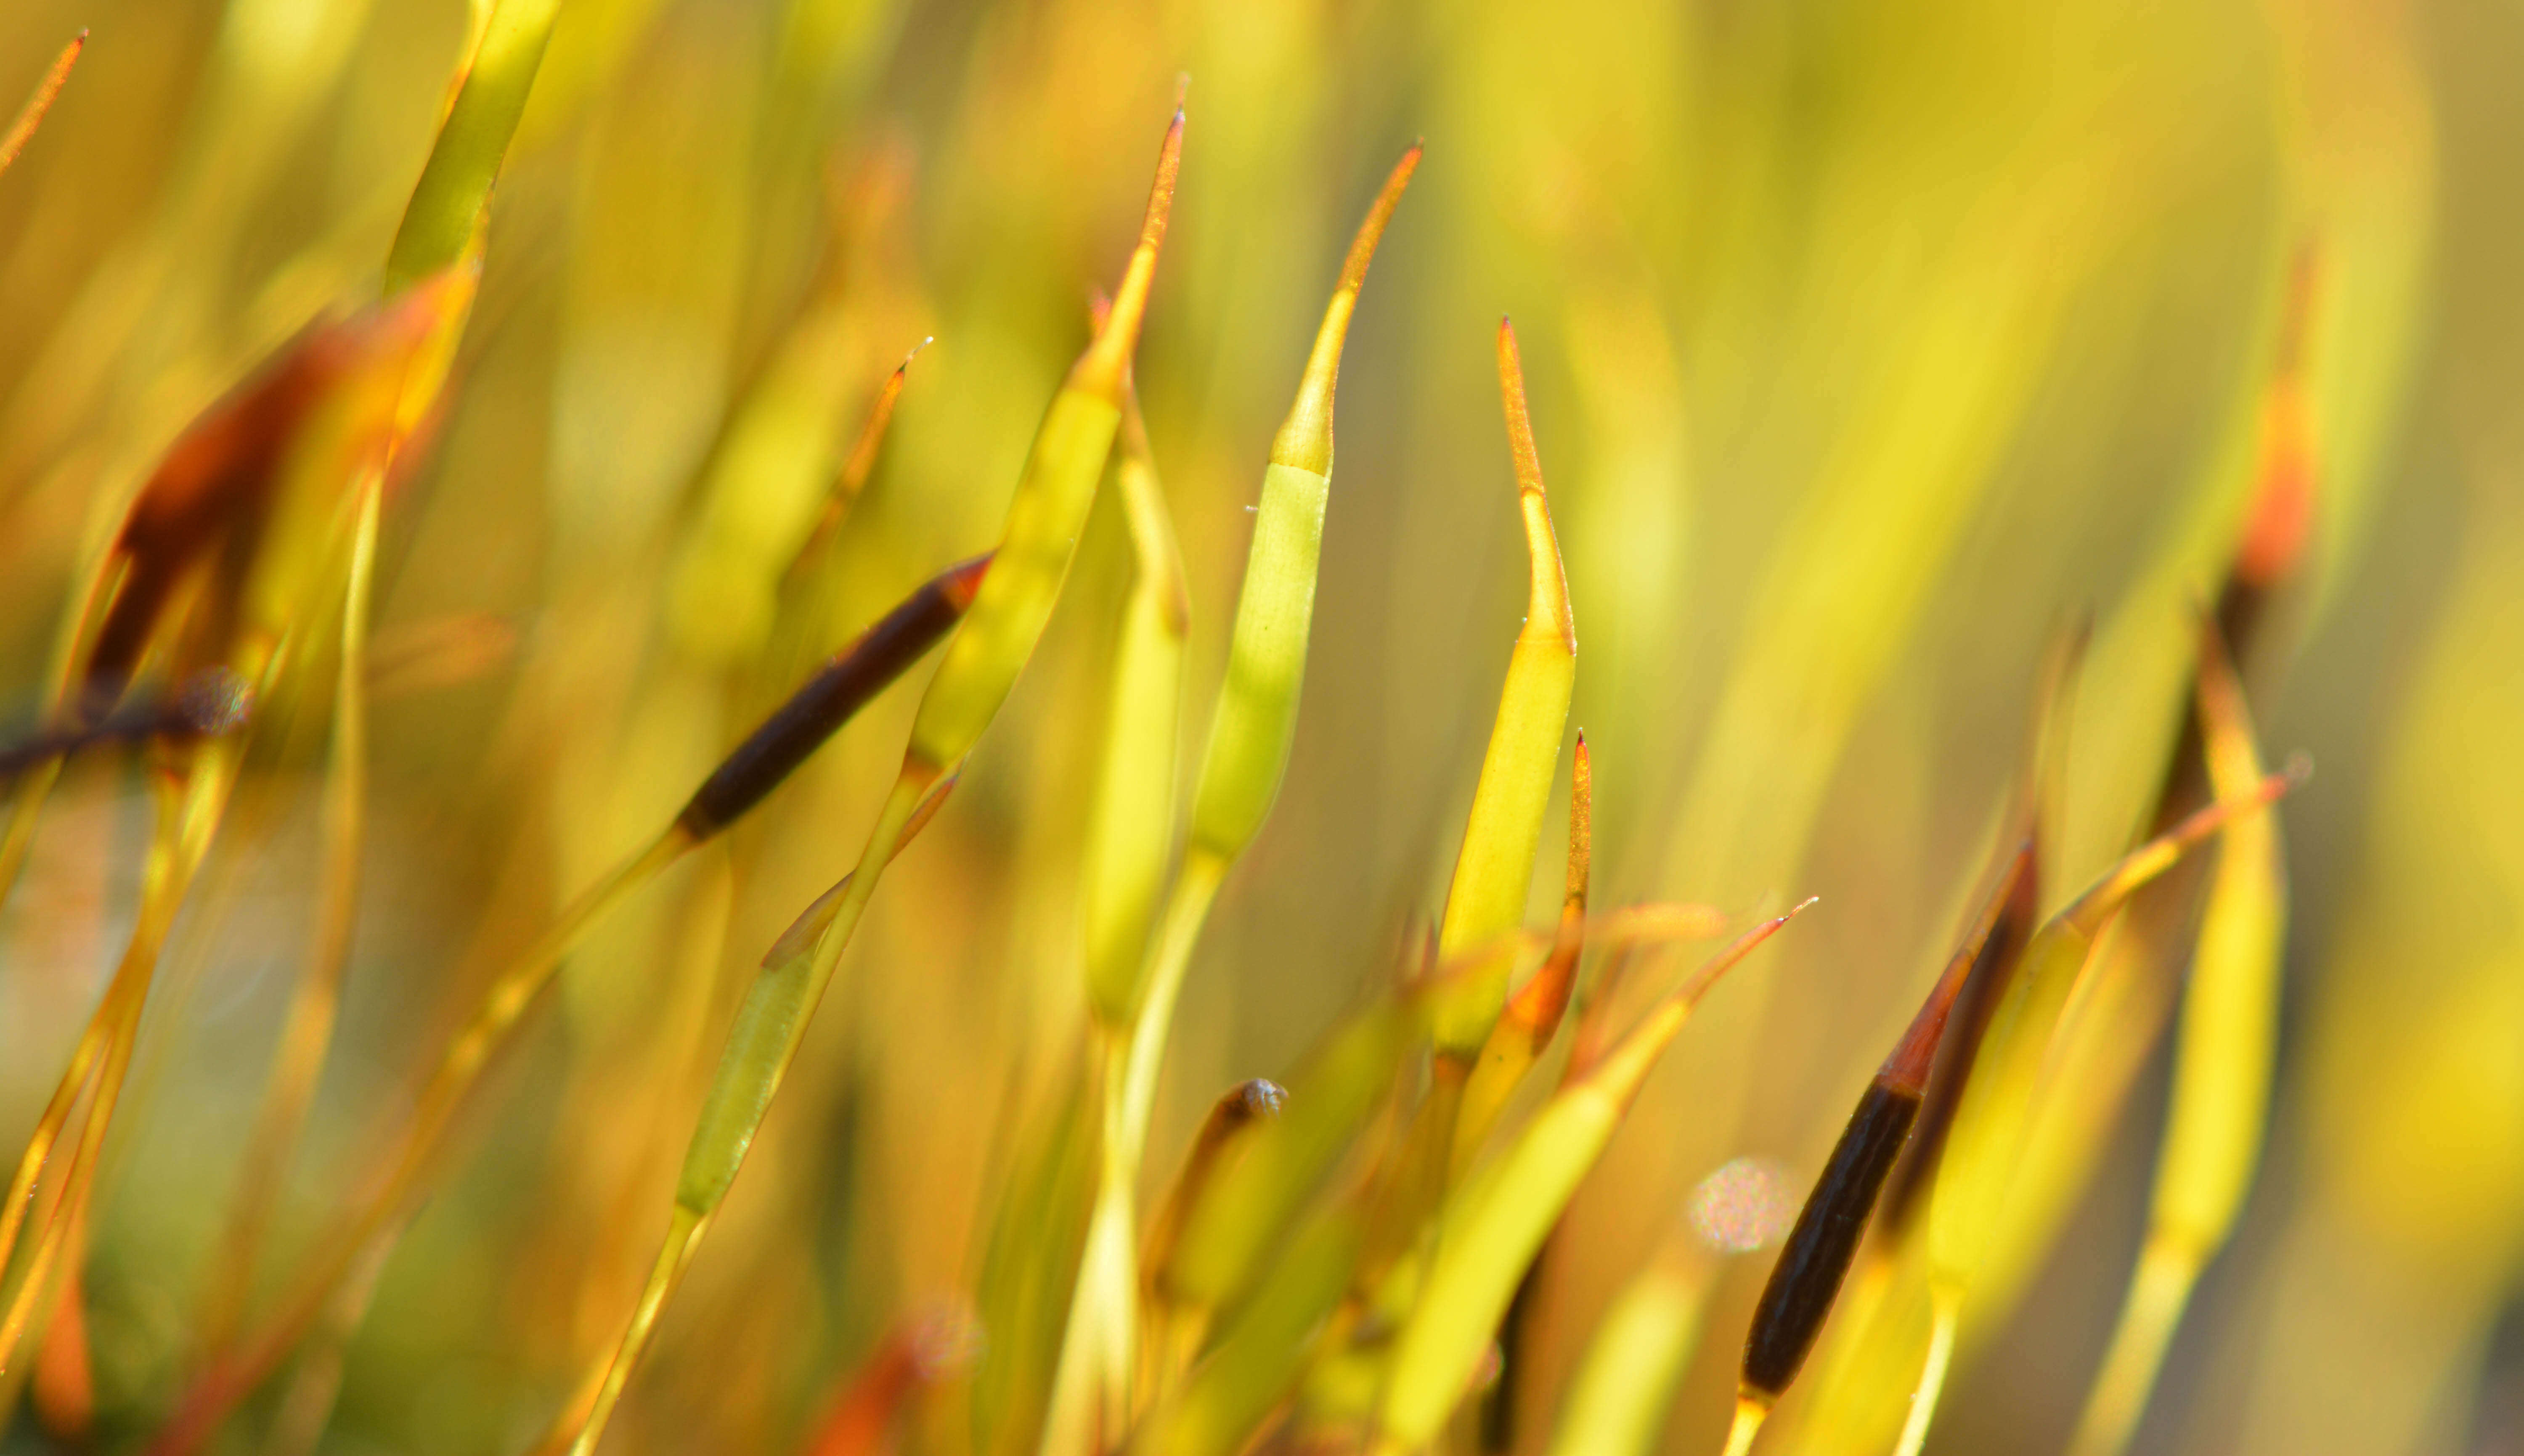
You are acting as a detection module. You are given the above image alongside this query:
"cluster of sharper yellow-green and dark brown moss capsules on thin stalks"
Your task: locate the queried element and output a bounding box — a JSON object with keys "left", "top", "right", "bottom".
{"left": 0, "top": 31, "right": 2304, "bottom": 1456}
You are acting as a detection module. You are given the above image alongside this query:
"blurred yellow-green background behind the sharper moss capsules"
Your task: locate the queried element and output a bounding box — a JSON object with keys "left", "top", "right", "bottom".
{"left": 0, "top": 0, "right": 2524, "bottom": 1456}
